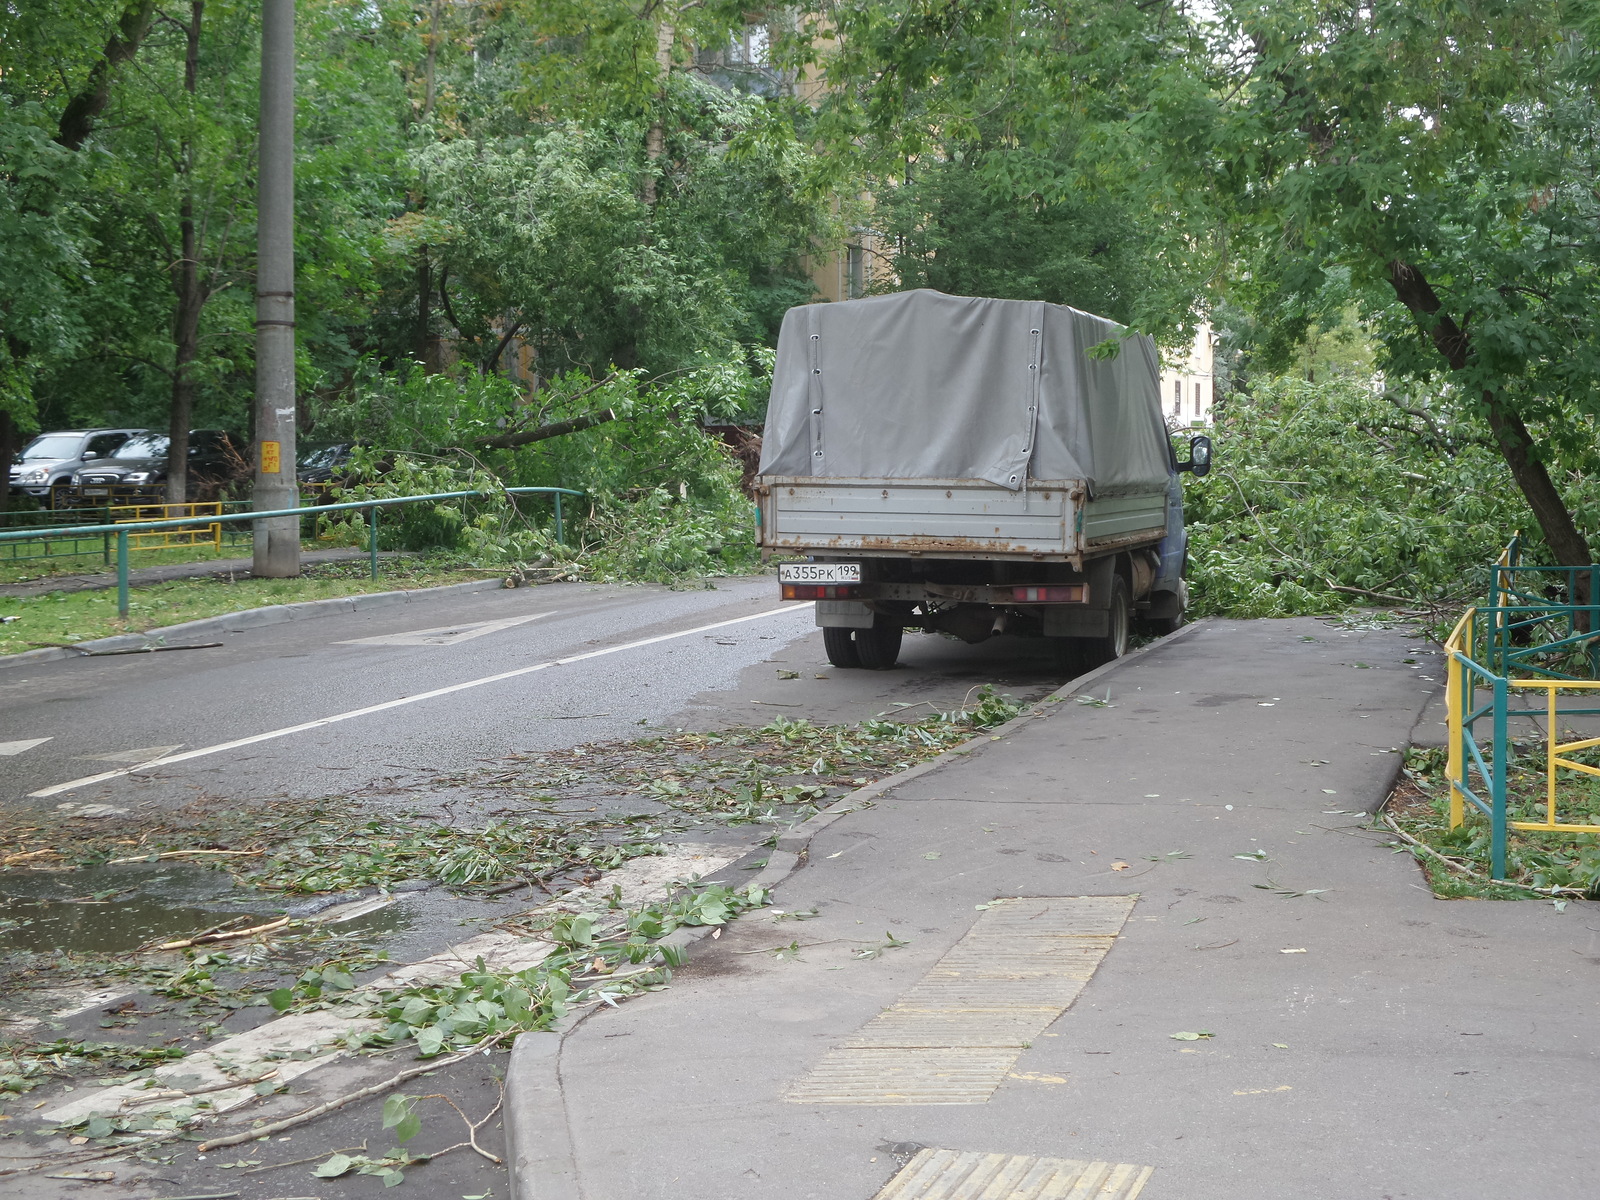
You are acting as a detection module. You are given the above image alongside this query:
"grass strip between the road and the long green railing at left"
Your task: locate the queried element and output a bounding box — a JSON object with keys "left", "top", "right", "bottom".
{"left": 0, "top": 558, "right": 485, "bottom": 654}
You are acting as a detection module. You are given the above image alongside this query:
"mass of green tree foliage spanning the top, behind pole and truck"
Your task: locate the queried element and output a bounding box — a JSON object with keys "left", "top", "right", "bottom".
{"left": 9, "top": 0, "right": 1600, "bottom": 590}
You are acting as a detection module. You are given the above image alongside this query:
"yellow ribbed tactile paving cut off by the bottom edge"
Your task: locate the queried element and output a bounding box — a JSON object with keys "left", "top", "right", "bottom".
{"left": 874, "top": 1149, "right": 1155, "bottom": 1200}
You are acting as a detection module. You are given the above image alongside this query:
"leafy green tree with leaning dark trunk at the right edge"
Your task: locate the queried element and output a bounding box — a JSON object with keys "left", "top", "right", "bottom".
{"left": 1196, "top": 0, "right": 1600, "bottom": 563}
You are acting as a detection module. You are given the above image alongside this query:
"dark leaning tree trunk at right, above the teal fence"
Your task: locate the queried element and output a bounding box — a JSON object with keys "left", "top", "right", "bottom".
{"left": 1389, "top": 259, "right": 1594, "bottom": 566}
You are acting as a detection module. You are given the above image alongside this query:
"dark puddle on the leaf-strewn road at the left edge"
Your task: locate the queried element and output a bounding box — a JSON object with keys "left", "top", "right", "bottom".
{"left": 0, "top": 862, "right": 294, "bottom": 954}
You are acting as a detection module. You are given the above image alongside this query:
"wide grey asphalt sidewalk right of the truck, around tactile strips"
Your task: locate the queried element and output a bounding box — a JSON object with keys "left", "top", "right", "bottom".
{"left": 540, "top": 619, "right": 1600, "bottom": 1200}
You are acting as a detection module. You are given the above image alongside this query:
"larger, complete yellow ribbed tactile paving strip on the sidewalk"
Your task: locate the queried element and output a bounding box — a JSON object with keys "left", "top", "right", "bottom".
{"left": 786, "top": 896, "right": 1138, "bottom": 1107}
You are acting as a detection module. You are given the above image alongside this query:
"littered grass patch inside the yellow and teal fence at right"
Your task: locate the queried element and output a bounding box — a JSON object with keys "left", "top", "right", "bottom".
{"left": 1384, "top": 742, "right": 1600, "bottom": 899}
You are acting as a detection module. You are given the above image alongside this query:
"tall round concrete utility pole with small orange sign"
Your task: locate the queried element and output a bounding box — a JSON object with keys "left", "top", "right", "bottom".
{"left": 251, "top": 0, "right": 299, "bottom": 579}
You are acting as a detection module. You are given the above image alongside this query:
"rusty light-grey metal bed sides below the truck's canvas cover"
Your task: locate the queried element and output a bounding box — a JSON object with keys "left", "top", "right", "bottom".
{"left": 758, "top": 475, "right": 1166, "bottom": 560}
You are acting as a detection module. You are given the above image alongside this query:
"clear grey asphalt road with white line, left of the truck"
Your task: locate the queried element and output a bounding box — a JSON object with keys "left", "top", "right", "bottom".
{"left": 0, "top": 578, "right": 1062, "bottom": 808}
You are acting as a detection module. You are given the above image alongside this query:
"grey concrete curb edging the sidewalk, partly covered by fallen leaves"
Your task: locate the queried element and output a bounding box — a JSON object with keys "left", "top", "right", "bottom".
{"left": 504, "top": 618, "right": 1211, "bottom": 1200}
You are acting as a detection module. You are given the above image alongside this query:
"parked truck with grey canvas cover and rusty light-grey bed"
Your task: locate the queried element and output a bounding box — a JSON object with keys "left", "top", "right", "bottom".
{"left": 755, "top": 290, "right": 1211, "bottom": 669}
